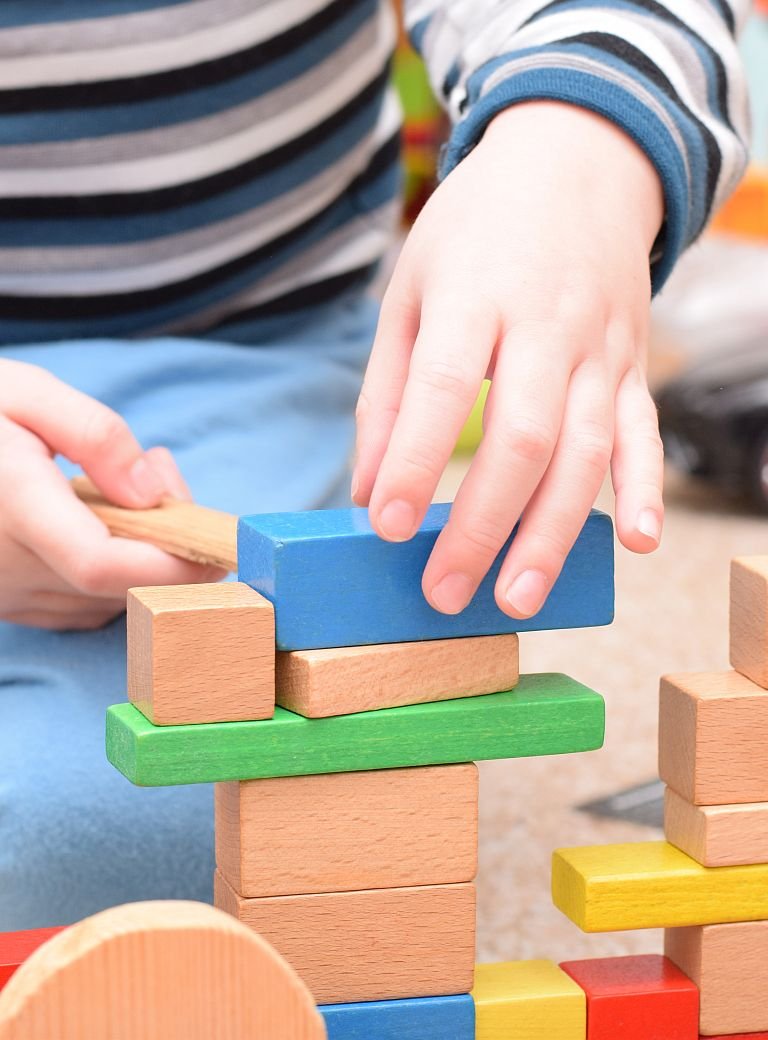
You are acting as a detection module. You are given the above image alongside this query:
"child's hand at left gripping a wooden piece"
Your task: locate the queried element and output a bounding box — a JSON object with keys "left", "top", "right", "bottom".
{"left": 0, "top": 360, "right": 222, "bottom": 628}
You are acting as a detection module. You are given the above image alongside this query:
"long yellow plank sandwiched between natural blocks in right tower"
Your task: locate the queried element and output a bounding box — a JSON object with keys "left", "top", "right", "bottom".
{"left": 552, "top": 841, "right": 768, "bottom": 932}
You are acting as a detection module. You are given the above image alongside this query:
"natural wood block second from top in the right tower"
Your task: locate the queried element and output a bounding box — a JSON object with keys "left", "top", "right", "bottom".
{"left": 659, "top": 672, "right": 768, "bottom": 805}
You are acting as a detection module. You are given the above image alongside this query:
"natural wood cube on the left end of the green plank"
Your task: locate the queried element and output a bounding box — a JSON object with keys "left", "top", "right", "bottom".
{"left": 128, "top": 582, "right": 275, "bottom": 726}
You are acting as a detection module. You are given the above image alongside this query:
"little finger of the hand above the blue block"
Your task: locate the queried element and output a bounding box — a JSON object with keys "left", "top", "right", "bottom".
{"left": 611, "top": 367, "right": 664, "bottom": 552}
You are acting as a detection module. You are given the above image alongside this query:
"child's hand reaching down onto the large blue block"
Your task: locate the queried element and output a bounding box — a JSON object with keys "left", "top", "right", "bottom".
{"left": 353, "top": 102, "right": 663, "bottom": 617}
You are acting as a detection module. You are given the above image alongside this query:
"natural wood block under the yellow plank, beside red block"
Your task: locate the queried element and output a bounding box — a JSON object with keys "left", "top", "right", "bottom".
{"left": 664, "top": 914, "right": 768, "bottom": 1036}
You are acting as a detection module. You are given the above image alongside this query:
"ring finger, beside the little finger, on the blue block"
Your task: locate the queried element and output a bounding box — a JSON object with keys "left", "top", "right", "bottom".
{"left": 495, "top": 365, "right": 613, "bottom": 618}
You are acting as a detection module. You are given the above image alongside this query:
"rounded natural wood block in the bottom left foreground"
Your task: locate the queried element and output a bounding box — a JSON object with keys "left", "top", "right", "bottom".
{"left": 0, "top": 902, "right": 326, "bottom": 1040}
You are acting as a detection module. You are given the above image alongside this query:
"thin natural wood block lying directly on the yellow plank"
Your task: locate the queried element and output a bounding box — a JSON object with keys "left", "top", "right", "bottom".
{"left": 664, "top": 787, "right": 768, "bottom": 866}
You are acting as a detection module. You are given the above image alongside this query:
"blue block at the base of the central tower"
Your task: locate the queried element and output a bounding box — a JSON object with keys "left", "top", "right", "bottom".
{"left": 317, "top": 993, "right": 475, "bottom": 1040}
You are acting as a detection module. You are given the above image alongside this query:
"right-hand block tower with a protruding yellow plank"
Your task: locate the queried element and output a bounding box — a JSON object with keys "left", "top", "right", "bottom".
{"left": 553, "top": 556, "right": 768, "bottom": 1040}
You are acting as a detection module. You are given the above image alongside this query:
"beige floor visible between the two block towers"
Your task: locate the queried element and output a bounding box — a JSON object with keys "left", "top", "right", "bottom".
{"left": 438, "top": 462, "right": 768, "bottom": 961}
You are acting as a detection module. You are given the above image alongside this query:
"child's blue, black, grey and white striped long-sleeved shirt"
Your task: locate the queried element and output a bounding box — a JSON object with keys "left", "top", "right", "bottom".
{"left": 0, "top": 0, "right": 746, "bottom": 344}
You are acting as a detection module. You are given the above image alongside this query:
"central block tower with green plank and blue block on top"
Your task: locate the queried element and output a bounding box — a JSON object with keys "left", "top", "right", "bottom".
{"left": 107, "top": 506, "right": 613, "bottom": 1040}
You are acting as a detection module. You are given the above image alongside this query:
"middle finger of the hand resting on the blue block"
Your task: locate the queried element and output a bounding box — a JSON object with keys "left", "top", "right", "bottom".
{"left": 423, "top": 328, "right": 569, "bottom": 614}
